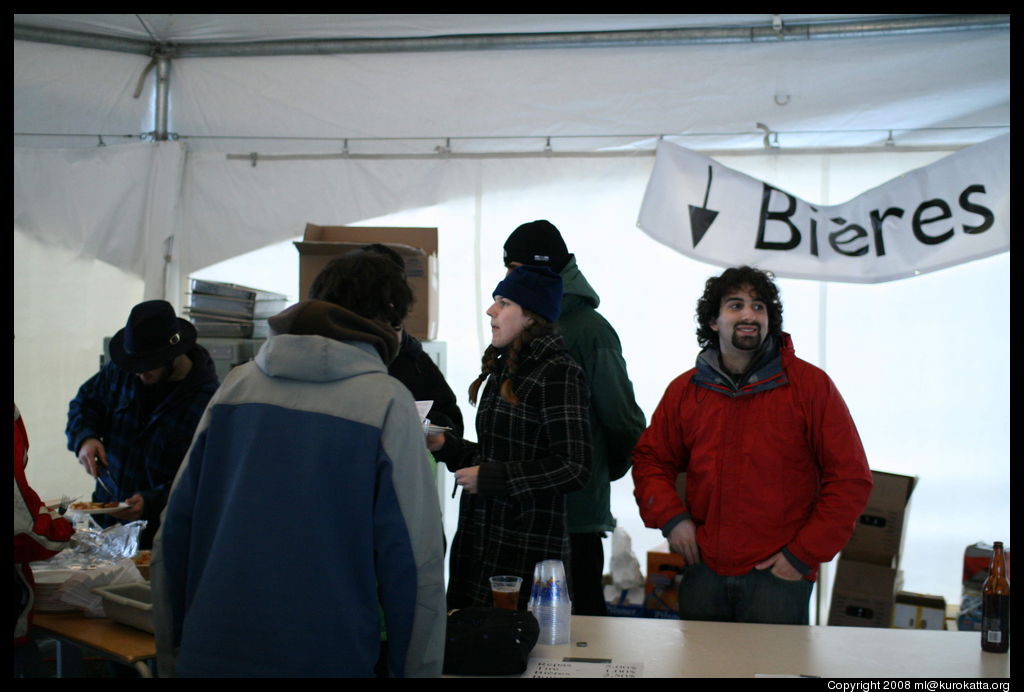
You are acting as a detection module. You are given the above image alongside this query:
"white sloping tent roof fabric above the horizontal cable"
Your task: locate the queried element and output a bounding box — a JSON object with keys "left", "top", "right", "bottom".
{"left": 14, "top": 14, "right": 1010, "bottom": 154}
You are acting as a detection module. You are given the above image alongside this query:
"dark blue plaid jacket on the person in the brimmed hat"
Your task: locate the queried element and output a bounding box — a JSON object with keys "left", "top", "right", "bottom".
{"left": 66, "top": 345, "right": 218, "bottom": 548}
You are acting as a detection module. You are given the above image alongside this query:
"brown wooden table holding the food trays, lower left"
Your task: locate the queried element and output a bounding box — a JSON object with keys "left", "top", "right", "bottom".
{"left": 33, "top": 612, "right": 157, "bottom": 678}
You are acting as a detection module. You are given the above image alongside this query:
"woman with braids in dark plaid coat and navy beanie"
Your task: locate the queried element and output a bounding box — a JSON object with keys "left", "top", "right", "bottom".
{"left": 432, "top": 266, "right": 591, "bottom": 609}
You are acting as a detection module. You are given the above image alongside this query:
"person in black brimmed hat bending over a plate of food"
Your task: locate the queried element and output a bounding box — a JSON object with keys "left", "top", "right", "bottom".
{"left": 66, "top": 300, "right": 218, "bottom": 549}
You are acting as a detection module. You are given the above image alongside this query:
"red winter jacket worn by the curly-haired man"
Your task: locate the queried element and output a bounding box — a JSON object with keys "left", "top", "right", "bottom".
{"left": 633, "top": 333, "right": 871, "bottom": 580}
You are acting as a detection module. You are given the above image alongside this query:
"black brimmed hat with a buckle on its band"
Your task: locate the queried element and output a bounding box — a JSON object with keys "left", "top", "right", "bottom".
{"left": 110, "top": 300, "right": 196, "bottom": 373}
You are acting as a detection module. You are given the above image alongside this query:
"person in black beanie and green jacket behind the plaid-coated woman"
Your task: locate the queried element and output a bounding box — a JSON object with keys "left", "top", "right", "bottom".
{"left": 505, "top": 220, "right": 646, "bottom": 615}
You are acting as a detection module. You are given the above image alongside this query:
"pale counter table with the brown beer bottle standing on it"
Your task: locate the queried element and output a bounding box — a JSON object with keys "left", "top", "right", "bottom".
{"left": 530, "top": 615, "right": 1010, "bottom": 689}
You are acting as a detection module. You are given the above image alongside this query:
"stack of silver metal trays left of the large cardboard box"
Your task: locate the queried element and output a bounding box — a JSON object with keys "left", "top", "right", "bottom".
{"left": 186, "top": 278, "right": 288, "bottom": 339}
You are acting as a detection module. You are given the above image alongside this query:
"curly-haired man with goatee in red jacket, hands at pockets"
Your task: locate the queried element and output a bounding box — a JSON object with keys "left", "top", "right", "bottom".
{"left": 633, "top": 267, "right": 871, "bottom": 624}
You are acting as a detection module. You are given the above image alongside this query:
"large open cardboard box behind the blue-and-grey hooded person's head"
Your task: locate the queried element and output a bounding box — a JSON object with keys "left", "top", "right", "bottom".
{"left": 295, "top": 223, "right": 437, "bottom": 341}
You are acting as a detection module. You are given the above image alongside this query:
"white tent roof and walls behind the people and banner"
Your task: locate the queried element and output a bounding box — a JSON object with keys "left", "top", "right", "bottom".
{"left": 13, "top": 14, "right": 1010, "bottom": 610}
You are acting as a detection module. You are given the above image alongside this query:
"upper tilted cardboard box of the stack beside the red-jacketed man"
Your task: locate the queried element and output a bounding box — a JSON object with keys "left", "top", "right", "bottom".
{"left": 842, "top": 471, "right": 918, "bottom": 569}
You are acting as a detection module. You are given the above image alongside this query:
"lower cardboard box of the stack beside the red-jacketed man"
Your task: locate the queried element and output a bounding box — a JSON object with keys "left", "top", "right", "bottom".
{"left": 828, "top": 558, "right": 902, "bottom": 628}
